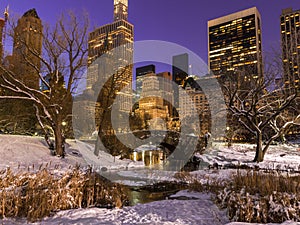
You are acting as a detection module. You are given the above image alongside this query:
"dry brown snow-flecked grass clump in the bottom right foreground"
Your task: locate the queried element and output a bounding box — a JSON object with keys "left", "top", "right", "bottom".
{"left": 216, "top": 170, "right": 300, "bottom": 223}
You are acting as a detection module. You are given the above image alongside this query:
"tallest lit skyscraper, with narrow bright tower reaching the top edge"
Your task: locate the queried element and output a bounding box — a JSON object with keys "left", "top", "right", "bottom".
{"left": 86, "top": 0, "right": 133, "bottom": 134}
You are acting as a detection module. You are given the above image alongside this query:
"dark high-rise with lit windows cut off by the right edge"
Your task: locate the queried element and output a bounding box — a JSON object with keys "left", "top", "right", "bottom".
{"left": 280, "top": 8, "right": 300, "bottom": 91}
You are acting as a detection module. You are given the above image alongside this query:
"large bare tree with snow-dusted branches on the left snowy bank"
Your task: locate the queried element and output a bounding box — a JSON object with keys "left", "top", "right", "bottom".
{"left": 0, "top": 13, "right": 89, "bottom": 156}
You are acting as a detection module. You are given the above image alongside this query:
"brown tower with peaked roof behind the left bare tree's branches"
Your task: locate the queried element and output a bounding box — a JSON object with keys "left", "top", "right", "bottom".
{"left": 11, "top": 9, "right": 43, "bottom": 89}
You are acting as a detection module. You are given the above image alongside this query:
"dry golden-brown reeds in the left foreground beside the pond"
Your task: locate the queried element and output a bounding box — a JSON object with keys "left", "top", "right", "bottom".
{"left": 0, "top": 167, "right": 128, "bottom": 221}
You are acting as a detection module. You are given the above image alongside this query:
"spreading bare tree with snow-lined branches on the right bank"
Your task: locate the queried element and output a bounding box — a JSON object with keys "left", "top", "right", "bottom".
{"left": 222, "top": 54, "right": 300, "bottom": 162}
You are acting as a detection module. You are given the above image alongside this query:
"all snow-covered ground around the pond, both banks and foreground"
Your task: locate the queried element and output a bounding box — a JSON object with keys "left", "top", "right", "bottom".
{"left": 0, "top": 135, "right": 300, "bottom": 225}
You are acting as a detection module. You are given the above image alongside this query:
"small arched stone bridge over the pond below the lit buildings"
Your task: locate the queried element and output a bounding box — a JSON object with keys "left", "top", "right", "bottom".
{"left": 94, "top": 130, "right": 199, "bottom": 170}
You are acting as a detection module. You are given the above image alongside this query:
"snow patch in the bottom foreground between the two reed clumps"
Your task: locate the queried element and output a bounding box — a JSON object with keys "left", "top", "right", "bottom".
{"left": 0, "top": 193, "right": 229, "bottom": 225}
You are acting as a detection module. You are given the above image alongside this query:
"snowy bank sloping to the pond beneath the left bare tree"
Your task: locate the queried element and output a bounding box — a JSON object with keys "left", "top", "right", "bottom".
{"left": 0, "top": 135, "right": 142, "bottom": 170}
